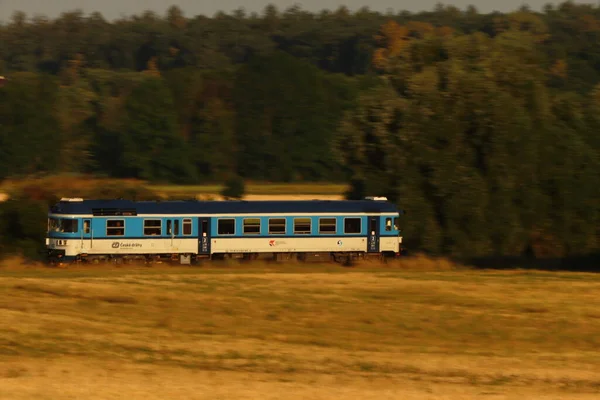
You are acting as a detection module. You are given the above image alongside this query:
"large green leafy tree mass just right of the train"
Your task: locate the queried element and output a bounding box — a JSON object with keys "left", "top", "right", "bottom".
{"left": 336, "top": 32, "right": 600, "bottom": 257}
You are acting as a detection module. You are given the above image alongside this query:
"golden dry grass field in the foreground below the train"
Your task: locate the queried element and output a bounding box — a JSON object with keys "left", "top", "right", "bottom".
{"left": 0, "top": 259, "right": 600, "bottom": 400}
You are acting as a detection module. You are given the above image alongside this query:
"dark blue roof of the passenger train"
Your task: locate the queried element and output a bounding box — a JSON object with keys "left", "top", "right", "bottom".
{"left": 50, "top": 199, "right": 400, "bottom": 216}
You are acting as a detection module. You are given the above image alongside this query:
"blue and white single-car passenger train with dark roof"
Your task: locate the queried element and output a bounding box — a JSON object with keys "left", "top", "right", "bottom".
{"left": 46, "top": 196, "right": 405, "bottom": 264}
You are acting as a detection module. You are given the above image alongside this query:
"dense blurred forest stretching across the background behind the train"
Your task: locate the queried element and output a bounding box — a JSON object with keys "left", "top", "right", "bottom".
{"left": 0, "top": 2, "right": 600, "bottom": 257}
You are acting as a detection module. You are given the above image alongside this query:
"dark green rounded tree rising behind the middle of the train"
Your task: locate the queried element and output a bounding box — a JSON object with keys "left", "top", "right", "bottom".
{"left": 234, "top": 53, "right": 344, "bottom": 181}
